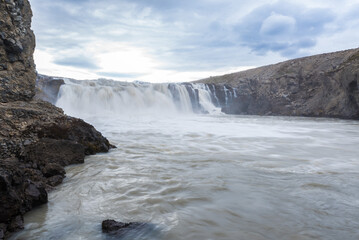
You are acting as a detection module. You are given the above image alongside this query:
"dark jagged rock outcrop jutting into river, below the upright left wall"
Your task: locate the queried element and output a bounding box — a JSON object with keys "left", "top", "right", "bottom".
{"left": 0, "top": 101, "right": 111, "bottom": 237}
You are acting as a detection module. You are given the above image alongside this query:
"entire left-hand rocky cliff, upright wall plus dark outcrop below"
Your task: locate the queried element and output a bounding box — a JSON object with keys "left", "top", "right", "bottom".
{"left": 0, "top": 0, "right": 111, "bottom": 239}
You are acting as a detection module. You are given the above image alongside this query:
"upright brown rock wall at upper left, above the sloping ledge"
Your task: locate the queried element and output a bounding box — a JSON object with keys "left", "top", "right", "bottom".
{"left": 0, "top": 0, "right": 36, "bottom": 102}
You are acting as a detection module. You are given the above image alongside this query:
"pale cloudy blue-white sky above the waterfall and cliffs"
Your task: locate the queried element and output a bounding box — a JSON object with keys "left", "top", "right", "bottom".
{"left": 30, "top": 0, "right": 359, "bottom": 82}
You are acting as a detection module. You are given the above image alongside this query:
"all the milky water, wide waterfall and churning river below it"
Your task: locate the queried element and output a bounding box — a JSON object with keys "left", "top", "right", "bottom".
{"left": 11, "top": 81, "right": 359, "bottom": 240}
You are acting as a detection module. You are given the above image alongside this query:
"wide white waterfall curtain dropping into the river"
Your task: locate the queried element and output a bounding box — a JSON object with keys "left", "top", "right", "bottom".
{"left": 56, "top": 79, "right": 221, "bottom": 117}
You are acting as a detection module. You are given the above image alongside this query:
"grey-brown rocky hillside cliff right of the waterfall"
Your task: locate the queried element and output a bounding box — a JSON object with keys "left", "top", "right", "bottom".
{"left": 197, "top": 49, "right": 359, "bottom": 119}
